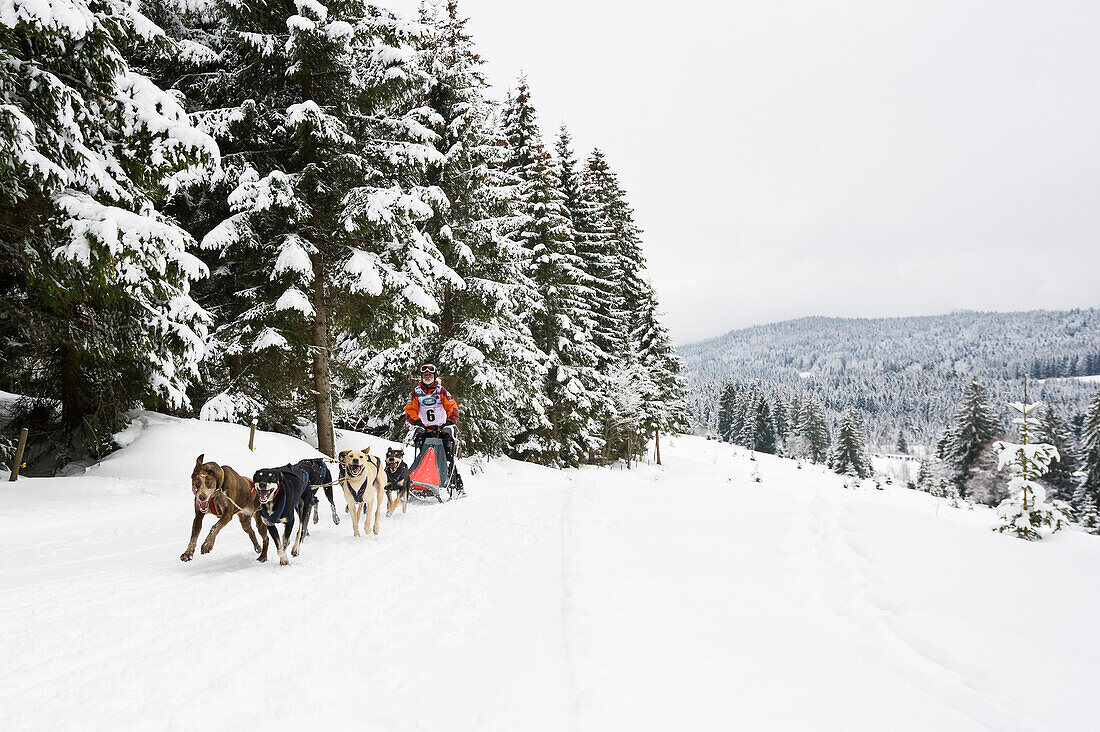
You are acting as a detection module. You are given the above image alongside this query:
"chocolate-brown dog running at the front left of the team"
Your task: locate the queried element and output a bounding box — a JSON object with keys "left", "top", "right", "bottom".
{"left": 179, "top": 455, "right": 267, "bottom": 561}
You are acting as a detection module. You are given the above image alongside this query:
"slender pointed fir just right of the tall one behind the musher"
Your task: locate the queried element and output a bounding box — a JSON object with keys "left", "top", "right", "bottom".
{"left": 503, "top": 77, "right": 603, "bottom": 466}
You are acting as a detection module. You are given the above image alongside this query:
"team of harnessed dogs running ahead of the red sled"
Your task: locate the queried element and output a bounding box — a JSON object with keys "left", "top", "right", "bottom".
{"left": 179, "top": 448, "right": 409, "bottom": 565}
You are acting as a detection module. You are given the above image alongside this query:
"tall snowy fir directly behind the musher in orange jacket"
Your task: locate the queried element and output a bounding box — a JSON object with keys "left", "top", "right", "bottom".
{"left": 353, "top": 0, "right": 549, "bottom": 455}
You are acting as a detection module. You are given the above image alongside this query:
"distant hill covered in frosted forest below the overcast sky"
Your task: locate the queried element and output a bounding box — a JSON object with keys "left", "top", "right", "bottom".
{"left": 679, "top": 308, "right": 1100, "bottom": 446}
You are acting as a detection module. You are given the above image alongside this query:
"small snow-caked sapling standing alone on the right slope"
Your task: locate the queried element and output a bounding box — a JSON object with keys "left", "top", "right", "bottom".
{"left": 993, "top": 381, "right": 1069, "bottom": 540}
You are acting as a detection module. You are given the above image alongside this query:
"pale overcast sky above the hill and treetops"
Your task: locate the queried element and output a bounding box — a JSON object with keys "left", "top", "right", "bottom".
{"left": 381, "top": 0, "right": 1100, "bottom": 343}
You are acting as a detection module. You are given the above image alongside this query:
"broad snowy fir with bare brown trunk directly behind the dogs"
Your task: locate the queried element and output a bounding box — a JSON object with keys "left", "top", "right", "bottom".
{"left": 184, "top": 0, "right": 451, "bottom": 455}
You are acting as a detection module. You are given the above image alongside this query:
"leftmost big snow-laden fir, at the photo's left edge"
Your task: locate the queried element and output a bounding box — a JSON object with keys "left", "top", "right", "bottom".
{"left": 0, "top": 0, "right": 219, "bottom": 469}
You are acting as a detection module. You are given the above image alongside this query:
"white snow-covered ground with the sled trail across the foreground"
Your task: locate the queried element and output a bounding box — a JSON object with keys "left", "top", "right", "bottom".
{"left": 0, "top": 414, "right": 1100, "bottom": 730}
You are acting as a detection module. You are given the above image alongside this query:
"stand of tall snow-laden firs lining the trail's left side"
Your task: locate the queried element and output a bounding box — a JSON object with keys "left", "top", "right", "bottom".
{"left": 0, "top": 0, "right": 689, "bottom": 473}
